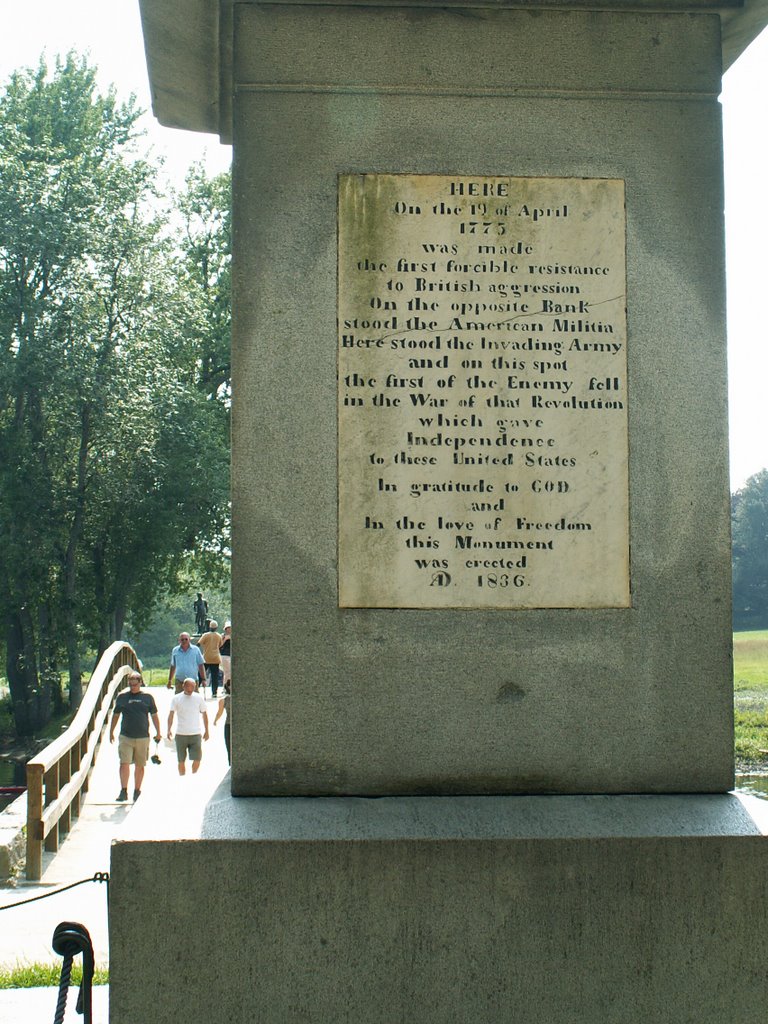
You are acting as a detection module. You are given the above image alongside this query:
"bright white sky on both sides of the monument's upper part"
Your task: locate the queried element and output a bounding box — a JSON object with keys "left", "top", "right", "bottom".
{"left": 0, "top": 0, "right": 768, "bottom": 490}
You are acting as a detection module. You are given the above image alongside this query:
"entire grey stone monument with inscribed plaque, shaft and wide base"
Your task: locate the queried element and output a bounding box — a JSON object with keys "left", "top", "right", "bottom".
{"left": 111, "top": 0, "right": 768, "bottom": 1024}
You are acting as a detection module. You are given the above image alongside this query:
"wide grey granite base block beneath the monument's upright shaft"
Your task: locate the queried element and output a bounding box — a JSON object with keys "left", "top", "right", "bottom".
{"left": 110, "top": 788, "right": 768, "bottom": 1024}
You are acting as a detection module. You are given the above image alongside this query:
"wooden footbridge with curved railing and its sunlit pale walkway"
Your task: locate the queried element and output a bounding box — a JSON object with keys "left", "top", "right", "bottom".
{"left": 0, "top": 643, "right": 228, "bottom": 966}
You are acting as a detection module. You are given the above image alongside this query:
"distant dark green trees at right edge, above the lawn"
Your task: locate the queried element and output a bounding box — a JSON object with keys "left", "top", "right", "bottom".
{"left": 731, "top": 469, "right": 768, "bottom": 629}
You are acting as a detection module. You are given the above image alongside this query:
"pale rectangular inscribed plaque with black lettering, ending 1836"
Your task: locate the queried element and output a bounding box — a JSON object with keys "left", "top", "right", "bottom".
{"left": 338, "top": 174, "right": 630, "bottom": 608}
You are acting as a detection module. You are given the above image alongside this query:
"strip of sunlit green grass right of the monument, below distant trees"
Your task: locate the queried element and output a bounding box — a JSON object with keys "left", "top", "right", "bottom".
{"left": 733, "top": 630, "right": 768, "bottom": 771}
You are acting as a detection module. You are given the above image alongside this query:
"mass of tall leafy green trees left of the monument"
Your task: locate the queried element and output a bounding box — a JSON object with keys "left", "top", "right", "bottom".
{"left": 0, "top": 54, "right": 228, "bottom": 734}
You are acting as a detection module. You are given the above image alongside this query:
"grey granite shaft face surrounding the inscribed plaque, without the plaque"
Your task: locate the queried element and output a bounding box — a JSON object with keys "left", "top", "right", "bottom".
{"left": 232, "top": 5, "right": 732, "bottom": 795}
